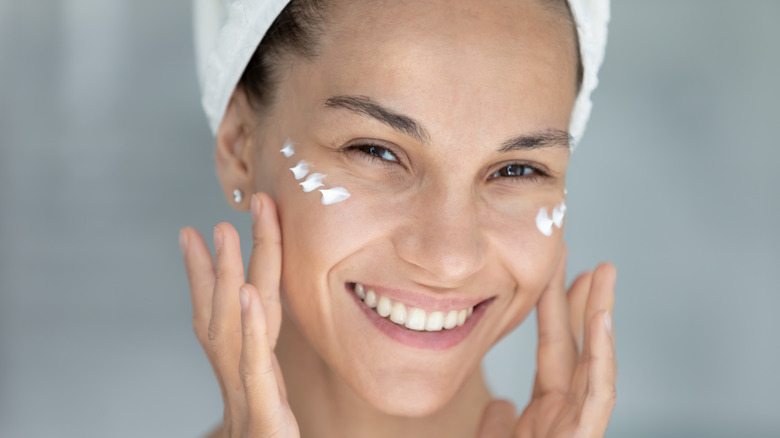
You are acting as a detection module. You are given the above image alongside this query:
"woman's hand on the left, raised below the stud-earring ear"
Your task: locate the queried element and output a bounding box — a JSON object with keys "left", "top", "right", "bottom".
{"left": 179, "top": 194, "right": 300, "bottom": 438}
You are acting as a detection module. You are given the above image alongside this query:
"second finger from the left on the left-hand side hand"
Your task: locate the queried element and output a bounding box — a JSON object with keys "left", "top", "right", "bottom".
{"left": 208, "top": 222, "right": 244, "bottom": 390}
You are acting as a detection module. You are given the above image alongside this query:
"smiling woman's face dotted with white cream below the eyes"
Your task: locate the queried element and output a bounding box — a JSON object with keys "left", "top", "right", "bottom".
{"left": 247, "top": 0, "right": 576, "bottom": 416}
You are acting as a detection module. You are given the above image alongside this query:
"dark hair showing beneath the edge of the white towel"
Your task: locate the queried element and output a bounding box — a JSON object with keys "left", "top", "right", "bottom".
{"left": 238, "top": 0, "right": 583, "bottom": 110}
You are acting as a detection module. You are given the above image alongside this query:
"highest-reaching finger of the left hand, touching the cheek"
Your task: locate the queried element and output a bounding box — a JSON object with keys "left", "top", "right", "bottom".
{"left": 247, "top": 193, "right": 282, "bottom": 349}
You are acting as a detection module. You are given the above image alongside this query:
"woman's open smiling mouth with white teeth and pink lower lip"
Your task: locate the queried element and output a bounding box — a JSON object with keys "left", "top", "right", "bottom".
{"left": 346, "top": 283, "right": 494, "bottom": 350}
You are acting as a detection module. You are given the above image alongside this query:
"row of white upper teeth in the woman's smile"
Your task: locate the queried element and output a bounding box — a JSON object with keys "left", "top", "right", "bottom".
{"left": 354, "top": 283, "right": 474, "bottom": 332}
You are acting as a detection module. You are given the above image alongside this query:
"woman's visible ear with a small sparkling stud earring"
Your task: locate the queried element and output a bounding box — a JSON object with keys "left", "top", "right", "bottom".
{"left": 214, "top": 87, "right": 256, "bottom": 210}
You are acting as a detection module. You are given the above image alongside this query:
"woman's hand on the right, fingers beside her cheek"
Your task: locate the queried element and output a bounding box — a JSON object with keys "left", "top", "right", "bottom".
{"left": 479, "top": 251, "right": 617, "bottom": 438}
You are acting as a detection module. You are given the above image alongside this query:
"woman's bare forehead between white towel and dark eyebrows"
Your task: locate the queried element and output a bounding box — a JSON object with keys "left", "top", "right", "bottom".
{"left": 290, "top": 0, "right": 576, "bottom": 146}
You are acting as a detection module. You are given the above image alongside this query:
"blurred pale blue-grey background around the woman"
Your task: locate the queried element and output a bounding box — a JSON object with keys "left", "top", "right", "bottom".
{"left": 0, "top": 0, "right": 780, "bottom": 437}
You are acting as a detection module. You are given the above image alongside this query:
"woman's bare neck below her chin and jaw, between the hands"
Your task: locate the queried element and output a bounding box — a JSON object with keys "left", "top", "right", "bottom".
{"left": 276, "top": 315, "right": 492, "bottom": 438}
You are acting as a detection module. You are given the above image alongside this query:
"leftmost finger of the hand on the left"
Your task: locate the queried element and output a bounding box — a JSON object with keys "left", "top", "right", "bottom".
{"left": 179, "top": 227, "right": 215, "bottom": 348}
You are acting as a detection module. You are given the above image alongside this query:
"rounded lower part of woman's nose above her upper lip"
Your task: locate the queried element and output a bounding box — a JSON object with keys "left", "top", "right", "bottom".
{"left": 393, "top": 187, "right": 486, "bottom": 287}
